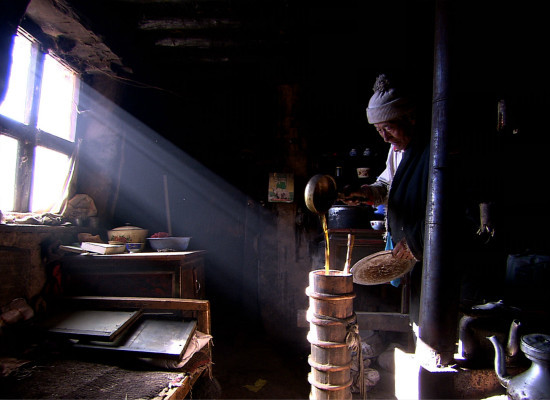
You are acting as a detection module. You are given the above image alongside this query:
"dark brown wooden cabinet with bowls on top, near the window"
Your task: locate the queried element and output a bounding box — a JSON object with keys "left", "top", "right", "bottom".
{"left": 61, "top": 250, "right": 205, "bottom": 299}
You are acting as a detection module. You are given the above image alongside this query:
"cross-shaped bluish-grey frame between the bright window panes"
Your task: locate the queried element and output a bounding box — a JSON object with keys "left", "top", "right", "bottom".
{"left": 0, "top": 27, "right": 81, "bottom": 213}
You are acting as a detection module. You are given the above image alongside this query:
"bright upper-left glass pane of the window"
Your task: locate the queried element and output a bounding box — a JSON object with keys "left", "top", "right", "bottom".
{"left": 0, "top": 35, "right": 32, "bottom": 123}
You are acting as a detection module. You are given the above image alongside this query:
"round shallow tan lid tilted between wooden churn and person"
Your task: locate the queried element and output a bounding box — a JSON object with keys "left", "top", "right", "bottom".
{"left": 351, "top": 250, "right": 416, "bottom": 285}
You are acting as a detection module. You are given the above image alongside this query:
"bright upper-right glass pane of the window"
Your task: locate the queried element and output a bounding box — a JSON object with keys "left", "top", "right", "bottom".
{"left": 38, "top": 55, "right": 76, "bottom": 141}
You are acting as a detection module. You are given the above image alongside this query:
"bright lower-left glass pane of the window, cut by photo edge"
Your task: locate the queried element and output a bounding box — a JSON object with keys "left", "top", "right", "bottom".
{"left": 0, "top": 135, "right": 17, "bottom": 211}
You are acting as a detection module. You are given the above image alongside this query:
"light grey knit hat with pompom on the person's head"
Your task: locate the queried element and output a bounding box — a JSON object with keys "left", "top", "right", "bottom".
{"left": 367, "top": 74, "right": 415, "bottom": 124}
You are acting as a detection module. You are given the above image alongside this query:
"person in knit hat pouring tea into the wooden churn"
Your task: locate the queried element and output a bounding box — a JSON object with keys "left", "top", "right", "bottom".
{"left": 343, "top": 74, "right": 430, "bottom": 322}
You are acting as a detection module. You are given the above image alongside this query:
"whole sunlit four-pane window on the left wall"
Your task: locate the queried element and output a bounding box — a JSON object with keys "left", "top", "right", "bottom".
{"left": 0, "top": 30, "right": 79, "bottom": 212}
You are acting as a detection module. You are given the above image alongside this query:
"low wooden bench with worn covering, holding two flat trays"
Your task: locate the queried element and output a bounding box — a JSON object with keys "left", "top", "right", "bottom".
{"left": 0, "top": 296, "right": 213, "bottom": 400}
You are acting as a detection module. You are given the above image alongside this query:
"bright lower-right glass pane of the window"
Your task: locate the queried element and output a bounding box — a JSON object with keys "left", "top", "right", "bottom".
{"left": 31, "top": 147, "right": 70, "bottom": 212}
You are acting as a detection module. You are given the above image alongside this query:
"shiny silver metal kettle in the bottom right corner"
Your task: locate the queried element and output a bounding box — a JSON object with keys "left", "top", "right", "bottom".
{"left": 488, "top": 321, "right": 550, "bottom": 400}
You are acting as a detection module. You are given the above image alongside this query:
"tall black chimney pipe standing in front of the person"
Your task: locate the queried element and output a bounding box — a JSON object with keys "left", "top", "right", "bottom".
{"left": 419, "top": 0, "right": 459, "bottom": 366}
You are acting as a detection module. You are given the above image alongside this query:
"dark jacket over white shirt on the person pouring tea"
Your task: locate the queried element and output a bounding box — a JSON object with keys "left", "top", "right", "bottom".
{"left": 387, "top": 138, "right": 430, "bottom": 260}
